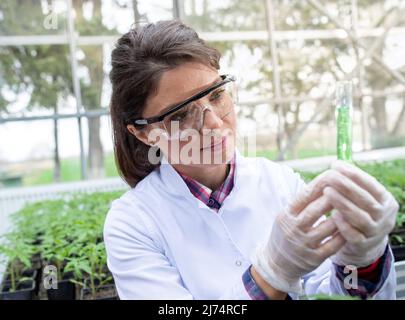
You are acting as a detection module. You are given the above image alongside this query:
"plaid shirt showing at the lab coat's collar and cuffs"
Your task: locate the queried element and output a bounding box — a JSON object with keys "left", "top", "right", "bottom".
{"left": 180, "top": 156, "right": 392, "bottom": 300}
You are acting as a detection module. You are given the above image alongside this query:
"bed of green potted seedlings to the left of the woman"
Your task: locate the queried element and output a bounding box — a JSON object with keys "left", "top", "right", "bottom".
{"left": 0, "top": 191, "right": 122, "bottom": 294}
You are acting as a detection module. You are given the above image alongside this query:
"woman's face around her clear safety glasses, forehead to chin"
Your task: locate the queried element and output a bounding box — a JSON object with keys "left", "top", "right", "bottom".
{"left": 138, "top": 62, "right": 236, "bottom": 166}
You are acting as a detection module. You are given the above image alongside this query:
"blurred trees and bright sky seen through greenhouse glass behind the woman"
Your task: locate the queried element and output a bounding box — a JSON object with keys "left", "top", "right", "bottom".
{"left": 0, "top": 0, "right": 405, "bottom": 185}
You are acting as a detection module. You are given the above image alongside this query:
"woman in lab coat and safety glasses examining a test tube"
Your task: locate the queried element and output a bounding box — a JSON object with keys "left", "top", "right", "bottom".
{"left": 104, "top": 21, "right": 398, "bottom": 299}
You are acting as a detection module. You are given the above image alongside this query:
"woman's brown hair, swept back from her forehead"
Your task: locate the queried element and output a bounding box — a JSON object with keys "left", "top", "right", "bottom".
{"left": 110, "top": 20, "right": 221, "bottom": 187}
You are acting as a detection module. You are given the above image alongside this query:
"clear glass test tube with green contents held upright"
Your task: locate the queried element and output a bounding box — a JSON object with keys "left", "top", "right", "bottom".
{"left": 336, "top": 81, "right": 353, "bottom": 162}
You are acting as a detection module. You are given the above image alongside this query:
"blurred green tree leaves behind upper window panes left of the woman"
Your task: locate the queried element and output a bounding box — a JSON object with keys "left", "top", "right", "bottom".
{"left": 0, "top": 0, "right": 116, "bottom": 112}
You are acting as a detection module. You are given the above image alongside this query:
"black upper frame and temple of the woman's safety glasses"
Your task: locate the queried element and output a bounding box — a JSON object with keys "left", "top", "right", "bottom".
{"left": 132, "top": 74, "right": 236, "bottom": 126}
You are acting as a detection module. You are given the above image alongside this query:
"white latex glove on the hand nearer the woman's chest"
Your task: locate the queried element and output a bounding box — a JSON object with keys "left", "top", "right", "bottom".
{"left": 253, "top": 182, "right": 345, "bottom": 294}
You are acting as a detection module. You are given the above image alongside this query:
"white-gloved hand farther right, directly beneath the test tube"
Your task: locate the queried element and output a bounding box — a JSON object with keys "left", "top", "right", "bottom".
{"left": 323, "top": 161, "right": 399, "bottom": 267}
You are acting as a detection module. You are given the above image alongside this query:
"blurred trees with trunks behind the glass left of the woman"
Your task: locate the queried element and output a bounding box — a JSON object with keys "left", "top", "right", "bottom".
{"left": 0, "top": 0, "right": 120, "bottom": 180}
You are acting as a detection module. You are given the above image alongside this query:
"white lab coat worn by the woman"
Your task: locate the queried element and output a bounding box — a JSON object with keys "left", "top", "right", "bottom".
{"left": 104, "top": 152, "right": 396, "bottom": 299}
